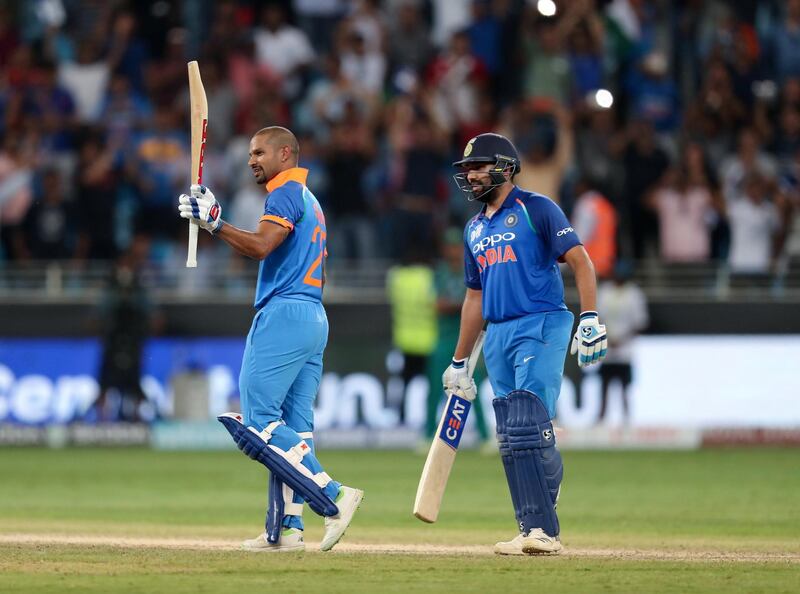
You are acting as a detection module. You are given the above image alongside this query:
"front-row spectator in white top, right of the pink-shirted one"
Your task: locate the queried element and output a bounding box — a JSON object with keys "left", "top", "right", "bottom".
{"left": 727, "top": 172, "right": 781, "bottom": 280}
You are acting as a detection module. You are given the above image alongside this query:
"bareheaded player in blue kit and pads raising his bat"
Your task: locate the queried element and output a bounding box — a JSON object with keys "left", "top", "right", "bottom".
{"left": 178, "top": 126, "right": 364, "bottom": 552}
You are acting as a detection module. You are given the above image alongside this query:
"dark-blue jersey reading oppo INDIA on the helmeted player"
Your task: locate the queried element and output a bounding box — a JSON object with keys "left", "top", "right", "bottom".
{"left": 464, "top": 186, "right": 581, "bottom": 322}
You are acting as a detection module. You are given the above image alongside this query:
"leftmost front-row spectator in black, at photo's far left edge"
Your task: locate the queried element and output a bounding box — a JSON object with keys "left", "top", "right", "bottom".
{"left": 14, "top": 169, "right": 77, "bottom": 260}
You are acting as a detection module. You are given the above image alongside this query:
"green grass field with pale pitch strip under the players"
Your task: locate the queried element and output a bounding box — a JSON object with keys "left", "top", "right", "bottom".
{"left": 0, "top": 449, "right": 800, "bottom": 594}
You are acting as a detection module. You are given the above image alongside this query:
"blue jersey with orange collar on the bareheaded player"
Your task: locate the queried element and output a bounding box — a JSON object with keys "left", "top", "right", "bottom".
{"left": 255, "top": 167, "right": 328, "bottom": 309}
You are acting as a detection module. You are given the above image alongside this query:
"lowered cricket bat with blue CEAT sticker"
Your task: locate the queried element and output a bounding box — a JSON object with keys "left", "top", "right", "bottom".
{"left": 414, "top": 329, "right": 486, "bottom": 524}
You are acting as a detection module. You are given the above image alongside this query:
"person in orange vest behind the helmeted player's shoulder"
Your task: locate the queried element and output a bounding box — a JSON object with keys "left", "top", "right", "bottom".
{"left": 570, "top": 179, "right": 617, "bottom": 279}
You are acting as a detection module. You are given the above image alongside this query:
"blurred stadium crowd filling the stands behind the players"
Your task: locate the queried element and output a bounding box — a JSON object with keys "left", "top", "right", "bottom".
{"left": 0, "top": 0, "right": 800, "bottom": 276}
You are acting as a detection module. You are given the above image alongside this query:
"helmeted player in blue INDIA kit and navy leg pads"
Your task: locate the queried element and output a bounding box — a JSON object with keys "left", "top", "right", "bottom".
{"left": 442, "top": 133, "right": 608, "bottom": 555}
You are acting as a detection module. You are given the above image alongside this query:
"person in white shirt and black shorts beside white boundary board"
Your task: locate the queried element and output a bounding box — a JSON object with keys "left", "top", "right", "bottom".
{"left": 597, "top": 261, "right": 649, "bottom": 423}
